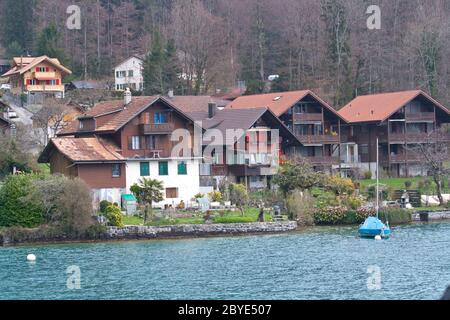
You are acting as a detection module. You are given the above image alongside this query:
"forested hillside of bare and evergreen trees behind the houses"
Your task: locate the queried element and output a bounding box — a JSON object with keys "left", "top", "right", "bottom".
{"left": 0, "top": 0, "right": 450, "bottom": 106}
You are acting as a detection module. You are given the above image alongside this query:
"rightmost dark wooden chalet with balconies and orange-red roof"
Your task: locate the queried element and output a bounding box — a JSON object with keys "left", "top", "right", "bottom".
{"left": 339, "top": 90, "right": 450, "bottom": 176}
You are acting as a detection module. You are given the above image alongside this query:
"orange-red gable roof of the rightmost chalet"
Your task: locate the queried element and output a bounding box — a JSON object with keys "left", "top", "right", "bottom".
{"left": 339, "top": 90, "right": 450, "bottom": 123}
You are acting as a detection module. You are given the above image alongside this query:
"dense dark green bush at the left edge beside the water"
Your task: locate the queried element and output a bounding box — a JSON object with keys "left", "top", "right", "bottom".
{"left": 0, "top": 174, "right": 44, "bottom": 228}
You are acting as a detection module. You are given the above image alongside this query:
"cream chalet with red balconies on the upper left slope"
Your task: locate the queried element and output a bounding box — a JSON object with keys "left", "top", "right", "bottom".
{"left": 1, "top": 56, "right": 72, "bottom": 98}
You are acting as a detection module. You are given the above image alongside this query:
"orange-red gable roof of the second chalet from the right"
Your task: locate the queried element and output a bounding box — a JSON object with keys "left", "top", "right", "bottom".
{"left": 227, "top": 90, "right": 344, "bottom": 120}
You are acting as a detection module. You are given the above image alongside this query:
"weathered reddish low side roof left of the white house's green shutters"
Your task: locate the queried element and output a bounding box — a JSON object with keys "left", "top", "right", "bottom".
{"left": 39, "top": 136, "right": 125, "bottom": 163}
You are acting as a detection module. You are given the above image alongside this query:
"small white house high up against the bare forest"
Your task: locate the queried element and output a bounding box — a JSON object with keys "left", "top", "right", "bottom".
{"left": 114, "top": 55, "right": 144, "bottom": 91}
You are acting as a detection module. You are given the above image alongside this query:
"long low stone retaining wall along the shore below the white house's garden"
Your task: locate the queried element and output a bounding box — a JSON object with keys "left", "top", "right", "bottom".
{"left": 107, "top": 222, "right": 297, "bottom": 240}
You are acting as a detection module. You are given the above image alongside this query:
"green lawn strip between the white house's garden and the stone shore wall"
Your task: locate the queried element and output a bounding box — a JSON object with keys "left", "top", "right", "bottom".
{"left": 123, "top": 208, "right": 272, "bottom": 227}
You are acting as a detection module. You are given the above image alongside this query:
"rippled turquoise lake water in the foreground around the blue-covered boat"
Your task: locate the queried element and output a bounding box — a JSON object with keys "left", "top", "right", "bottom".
{"left": 0, "top": 223, "right": 450, "bottom": 299}
